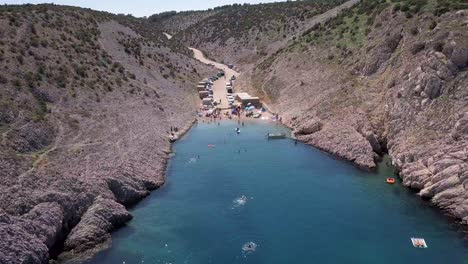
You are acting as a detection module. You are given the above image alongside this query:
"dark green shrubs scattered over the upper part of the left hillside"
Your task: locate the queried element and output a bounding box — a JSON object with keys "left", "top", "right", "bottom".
{"left": 0, "top": 5, "right": 199, "bottom": 124}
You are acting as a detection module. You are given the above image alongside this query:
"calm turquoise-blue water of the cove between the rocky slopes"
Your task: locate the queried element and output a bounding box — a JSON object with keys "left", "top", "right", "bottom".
{"left": 88, "top": 122, "right": 468, "bottom": 264}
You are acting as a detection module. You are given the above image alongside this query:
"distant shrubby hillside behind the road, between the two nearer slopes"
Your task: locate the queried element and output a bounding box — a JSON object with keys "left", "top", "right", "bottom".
{"left": 175, "top": 0, "right": 350, "bottom": 64}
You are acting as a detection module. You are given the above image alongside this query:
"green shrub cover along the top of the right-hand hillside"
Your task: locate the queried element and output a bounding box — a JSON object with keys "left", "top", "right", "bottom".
{"left": 270, "top": 0, "right": 468, "bottom": 68}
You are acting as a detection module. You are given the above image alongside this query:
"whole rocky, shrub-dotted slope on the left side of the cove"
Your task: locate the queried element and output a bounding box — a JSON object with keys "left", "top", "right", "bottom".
{"left": 0, "top": 5, "right": 208, "bottom": 264}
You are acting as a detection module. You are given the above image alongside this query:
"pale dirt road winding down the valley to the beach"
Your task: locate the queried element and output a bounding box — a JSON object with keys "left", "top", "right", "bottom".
{"left": 189, "top": 48, "right": 240, "bottom": 109}
